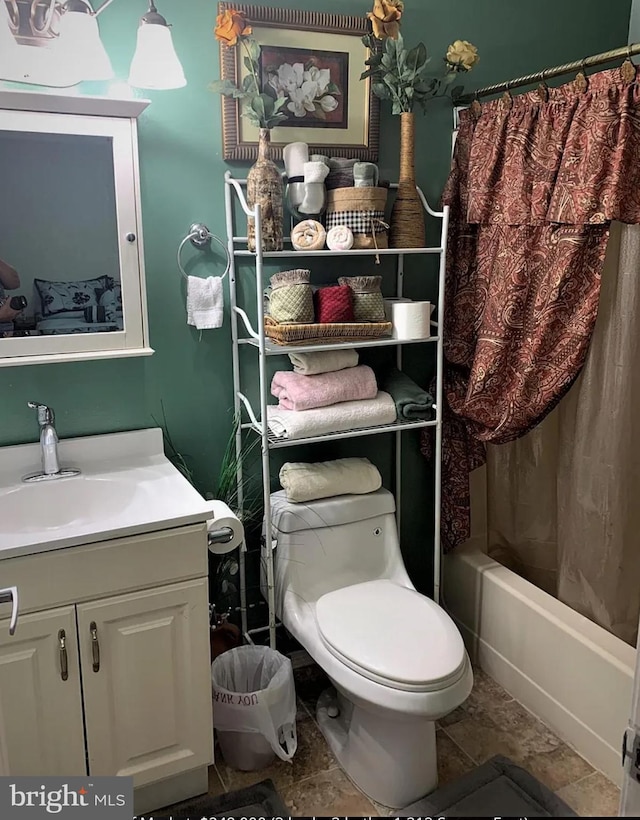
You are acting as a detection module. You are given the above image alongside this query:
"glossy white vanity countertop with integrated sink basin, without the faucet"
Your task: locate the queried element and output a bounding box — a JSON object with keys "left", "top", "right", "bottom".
{"left": 0, "top": 428, "right": 211, "bottom": 559}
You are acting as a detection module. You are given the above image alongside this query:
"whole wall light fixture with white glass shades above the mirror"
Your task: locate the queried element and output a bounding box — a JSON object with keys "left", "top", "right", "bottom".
{"left": 0, "top": 0, "right": 186, "bottom": 89}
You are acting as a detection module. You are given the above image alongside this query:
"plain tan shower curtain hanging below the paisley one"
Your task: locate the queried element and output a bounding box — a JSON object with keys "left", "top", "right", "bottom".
{"left": 487, "top": 223, "right": 640, "bottom": 645}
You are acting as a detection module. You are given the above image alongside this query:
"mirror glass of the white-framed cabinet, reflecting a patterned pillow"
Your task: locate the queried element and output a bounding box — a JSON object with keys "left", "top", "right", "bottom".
{"left": 0, "top": 130, "right": 124, "bottom": 339}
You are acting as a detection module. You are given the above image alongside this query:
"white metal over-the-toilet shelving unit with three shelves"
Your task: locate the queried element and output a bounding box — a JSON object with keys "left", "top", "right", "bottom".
{"left": 225, "top": 171, "right": 449, "bottom": 648}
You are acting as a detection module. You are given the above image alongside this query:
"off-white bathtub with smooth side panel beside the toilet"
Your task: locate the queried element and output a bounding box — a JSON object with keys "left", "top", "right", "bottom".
{"left": 443, "top": 545, "right": 635, "bottom": 785}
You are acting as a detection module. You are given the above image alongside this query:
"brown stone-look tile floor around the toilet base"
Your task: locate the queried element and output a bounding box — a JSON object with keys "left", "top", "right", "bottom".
{"left": 179, "top": 667, "right": 619, "bottom": 817}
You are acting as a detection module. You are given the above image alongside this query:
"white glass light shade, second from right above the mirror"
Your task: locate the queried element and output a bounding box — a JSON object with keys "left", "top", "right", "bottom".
{"left": 55, "top": 11, "right": 115, "bottom": 81}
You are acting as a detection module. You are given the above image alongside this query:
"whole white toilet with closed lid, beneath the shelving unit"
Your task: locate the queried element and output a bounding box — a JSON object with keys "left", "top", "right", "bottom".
{"left": 261, "top": 490, "right": 473, "bottom": 808}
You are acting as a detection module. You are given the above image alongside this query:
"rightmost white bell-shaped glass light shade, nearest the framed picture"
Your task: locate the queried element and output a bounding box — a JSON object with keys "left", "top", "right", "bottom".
{"left": 129, "top": 23, "right": 187, "bottom": 90}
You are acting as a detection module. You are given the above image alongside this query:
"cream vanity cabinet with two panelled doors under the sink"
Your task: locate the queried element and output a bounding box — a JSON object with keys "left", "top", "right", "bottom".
{"left": 0, "top": 524, "right": 213, "bottom": 812}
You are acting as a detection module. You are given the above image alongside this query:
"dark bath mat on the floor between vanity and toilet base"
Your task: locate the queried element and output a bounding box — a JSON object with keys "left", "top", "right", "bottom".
{"left": 156, "top": 780, "right": 291, "bottom": 820}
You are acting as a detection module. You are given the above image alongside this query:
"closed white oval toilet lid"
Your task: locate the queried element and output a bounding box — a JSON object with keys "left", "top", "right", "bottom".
{"left": 316, "top": 580, "right": 466, "bottom": 692}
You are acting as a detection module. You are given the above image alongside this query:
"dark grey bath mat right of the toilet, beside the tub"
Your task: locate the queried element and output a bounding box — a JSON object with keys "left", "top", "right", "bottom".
{"left": 403, "top": 755, "right": 578, "bottom": 817}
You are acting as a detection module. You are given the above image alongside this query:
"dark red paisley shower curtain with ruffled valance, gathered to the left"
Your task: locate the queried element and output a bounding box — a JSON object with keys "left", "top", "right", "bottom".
{"left": 424, "top": 69, "right": 640, "bottom": 572}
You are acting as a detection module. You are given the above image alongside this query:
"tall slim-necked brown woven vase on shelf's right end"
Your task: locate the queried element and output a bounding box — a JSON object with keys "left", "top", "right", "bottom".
{"left": 389, "top": 112, "right": 425, "bottom": 248}
